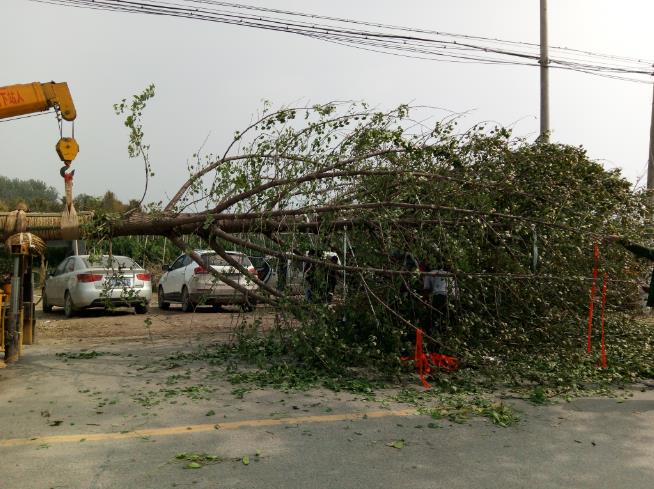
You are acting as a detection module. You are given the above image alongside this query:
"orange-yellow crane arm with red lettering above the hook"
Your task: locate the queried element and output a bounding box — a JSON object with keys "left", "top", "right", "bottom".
{"left": 0, "top": 82, "right": 77, "bottom": 121}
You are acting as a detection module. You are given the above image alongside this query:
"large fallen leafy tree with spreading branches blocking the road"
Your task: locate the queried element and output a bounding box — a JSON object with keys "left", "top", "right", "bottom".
{"left": 92, "top": 98, "right": 647, "bottom": 372}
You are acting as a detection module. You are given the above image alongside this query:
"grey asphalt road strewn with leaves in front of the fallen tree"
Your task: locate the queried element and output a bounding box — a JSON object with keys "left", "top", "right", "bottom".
{"left": 0, "top": 306, "right": 654, "bottom": 489}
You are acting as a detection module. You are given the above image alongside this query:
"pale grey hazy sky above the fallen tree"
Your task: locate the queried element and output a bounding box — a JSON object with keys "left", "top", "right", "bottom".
{"left": 0, "top": 0, "right": 654, "bottom": 201}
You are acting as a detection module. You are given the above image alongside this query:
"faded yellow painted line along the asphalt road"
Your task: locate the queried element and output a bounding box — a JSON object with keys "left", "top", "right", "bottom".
{"left": 0, "top": 409, "right": 418, "bottom": 447}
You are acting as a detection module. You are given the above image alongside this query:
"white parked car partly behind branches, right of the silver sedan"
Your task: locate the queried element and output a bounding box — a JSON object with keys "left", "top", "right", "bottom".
{"left": 157, "top": 250, "right": 257, "bottom": 312}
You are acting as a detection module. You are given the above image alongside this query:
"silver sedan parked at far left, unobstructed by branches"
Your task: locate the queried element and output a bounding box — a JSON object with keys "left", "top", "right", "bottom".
{"left": 41, "top": 255, "right": 152, "bottom": 317}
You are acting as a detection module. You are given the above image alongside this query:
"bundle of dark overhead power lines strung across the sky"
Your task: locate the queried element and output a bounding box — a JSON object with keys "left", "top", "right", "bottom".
{"left": 31, "top": 0, "right": 654, "bottom": 83}
